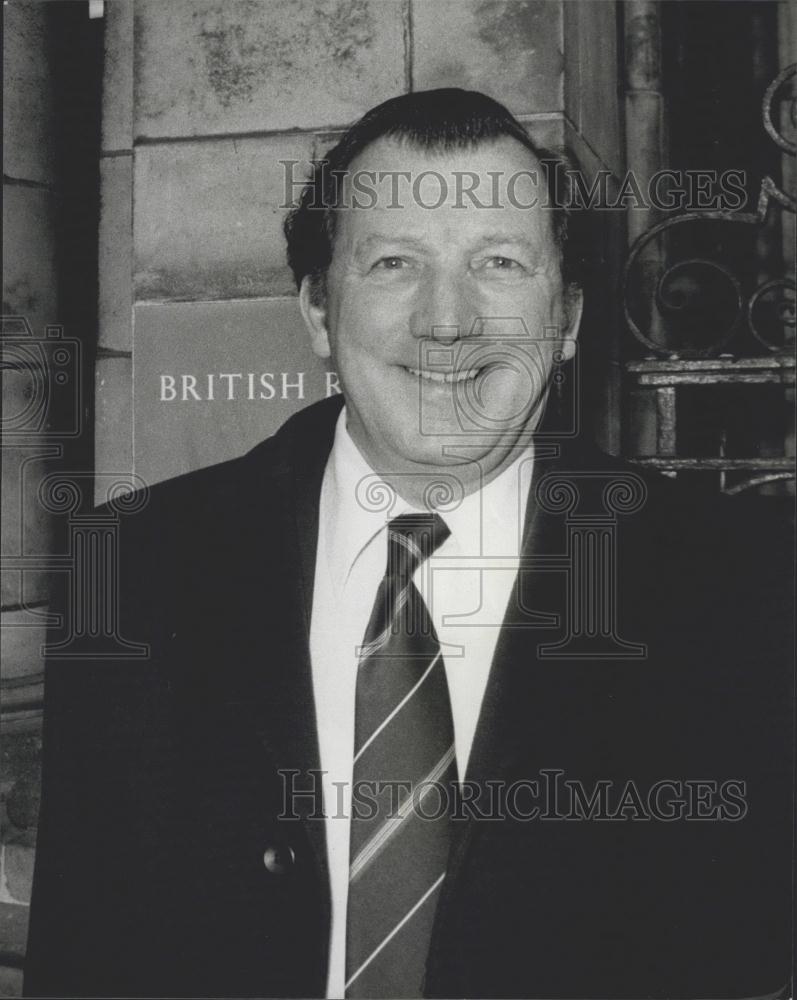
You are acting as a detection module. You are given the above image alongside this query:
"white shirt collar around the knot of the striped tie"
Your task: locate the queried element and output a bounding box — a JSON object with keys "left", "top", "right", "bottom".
{"left": 322, "top": 406, "right": 533, "bottom": 586}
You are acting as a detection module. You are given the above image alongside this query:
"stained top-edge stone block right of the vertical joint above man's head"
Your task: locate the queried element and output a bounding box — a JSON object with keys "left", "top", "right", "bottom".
{"left": 412, "top": 0, "right": 564, "bottom": 115}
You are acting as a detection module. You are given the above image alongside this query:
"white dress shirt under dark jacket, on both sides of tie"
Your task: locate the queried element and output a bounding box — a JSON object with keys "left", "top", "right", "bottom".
{"left": 310, "top": 408, "right": 532, "bottom": 997}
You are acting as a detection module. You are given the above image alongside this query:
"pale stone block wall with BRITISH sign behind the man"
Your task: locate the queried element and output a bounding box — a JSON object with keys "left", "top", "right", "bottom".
{"left": 96, "top": 0, "right": 622, "bottom": 496}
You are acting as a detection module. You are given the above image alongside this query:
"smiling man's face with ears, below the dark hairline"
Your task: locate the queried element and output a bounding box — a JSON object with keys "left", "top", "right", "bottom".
{"left": 302, "top": 137, "right": 580, "bottom": 492}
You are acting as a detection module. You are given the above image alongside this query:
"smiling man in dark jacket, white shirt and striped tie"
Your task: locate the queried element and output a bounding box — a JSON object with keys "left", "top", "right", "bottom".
{"left": 26, "top": 90, "right": 791, "bottom": 997}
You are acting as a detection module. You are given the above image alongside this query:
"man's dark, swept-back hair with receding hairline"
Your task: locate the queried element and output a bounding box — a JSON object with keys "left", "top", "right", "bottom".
{"left": 284, "top": 88, "right": 585, "bottom": 301}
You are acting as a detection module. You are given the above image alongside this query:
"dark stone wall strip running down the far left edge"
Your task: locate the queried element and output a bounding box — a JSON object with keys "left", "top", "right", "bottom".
{"left": 0, "top": 4, "right": 58, "bottom": 996}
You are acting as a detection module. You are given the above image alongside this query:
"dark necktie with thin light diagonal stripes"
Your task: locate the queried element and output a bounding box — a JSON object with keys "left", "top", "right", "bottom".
{"left": 346, "top": 514, "right": 457, "bottom": 997}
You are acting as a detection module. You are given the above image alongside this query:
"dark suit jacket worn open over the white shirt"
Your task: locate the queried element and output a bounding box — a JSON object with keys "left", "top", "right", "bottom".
{"left": 25, "top": 399, "right": 792, "bottom": 998}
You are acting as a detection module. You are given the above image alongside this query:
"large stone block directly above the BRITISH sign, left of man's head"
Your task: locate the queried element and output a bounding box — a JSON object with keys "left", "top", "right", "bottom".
{"left": 134, "top": 135, "right": 313, "bottom": 301}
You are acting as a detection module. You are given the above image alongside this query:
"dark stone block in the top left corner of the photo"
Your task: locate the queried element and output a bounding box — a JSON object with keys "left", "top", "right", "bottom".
{"left": 3, "top": 3, "right": 55, "bottom": 184}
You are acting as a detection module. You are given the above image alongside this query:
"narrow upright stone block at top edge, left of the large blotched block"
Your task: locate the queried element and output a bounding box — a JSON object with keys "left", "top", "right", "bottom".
{"left": 102, "top": 0, "right": 133, "bottom": 150}
